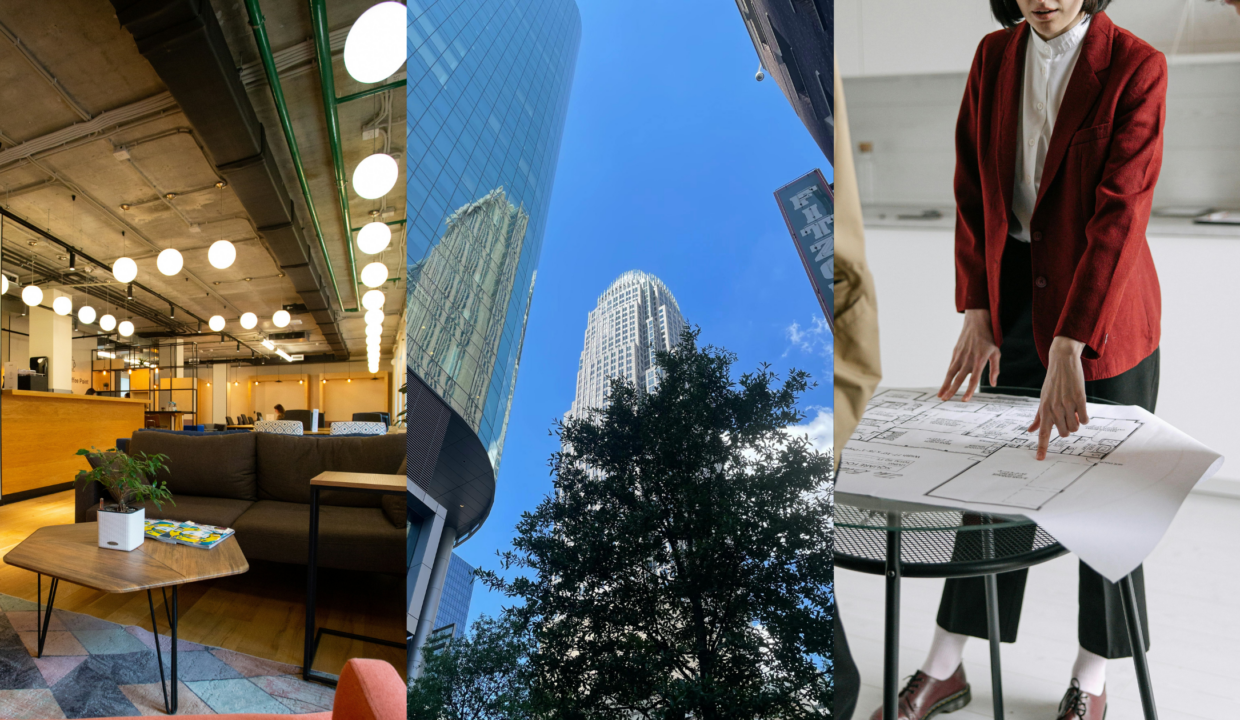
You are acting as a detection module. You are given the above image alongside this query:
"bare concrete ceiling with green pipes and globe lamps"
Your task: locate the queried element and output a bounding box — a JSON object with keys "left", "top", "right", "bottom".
{"left": 0, "top": 0, "right": 405, "bottom": 358}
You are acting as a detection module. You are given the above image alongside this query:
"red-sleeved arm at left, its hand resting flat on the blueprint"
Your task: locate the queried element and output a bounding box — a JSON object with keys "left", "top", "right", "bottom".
{"left": 939, "top": 42, "right": 999, "bottom": 402}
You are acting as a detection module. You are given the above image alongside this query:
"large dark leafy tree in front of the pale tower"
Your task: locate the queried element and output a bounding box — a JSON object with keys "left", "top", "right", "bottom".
{"left": 480, "top": 330, "right": 831, "bottom": 720}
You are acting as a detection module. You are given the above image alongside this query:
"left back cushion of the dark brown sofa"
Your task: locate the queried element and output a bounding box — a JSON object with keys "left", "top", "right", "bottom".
{"left": 129, "top": 431, "right": 258, "bottom": 500}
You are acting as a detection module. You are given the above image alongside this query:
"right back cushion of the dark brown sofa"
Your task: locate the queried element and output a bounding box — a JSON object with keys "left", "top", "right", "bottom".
{"left": 255, "top": 434, "right": 405, "bottom": 508}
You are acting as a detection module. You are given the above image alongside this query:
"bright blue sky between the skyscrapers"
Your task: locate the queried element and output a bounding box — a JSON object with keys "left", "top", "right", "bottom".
{"left": 456, "top": 0, "right": 832, "bottom": 621}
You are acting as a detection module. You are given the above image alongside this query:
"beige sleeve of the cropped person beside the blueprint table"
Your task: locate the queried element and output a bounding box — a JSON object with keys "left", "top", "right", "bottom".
{"left": 835, "top": 54, "right": 883, "bottom": 466}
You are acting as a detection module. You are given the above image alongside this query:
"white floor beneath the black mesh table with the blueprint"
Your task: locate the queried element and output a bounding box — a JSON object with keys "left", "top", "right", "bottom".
{"left": 836, "top": 493, "right": 1240, "bottom": 720}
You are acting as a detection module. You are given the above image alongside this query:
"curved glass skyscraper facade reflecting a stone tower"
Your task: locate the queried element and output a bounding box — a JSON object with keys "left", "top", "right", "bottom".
{"left": 405, "top": 0, "right": 582, "bottom": 674}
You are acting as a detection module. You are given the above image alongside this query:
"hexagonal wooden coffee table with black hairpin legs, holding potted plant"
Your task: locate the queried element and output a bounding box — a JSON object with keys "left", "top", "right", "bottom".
{"left": 4, "top": 523, "right": 249, "bottom": 715}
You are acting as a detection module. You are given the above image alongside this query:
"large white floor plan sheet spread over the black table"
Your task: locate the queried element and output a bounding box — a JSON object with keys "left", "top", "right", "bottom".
{"left": 836, "top": 388, "right": 1223, "bottom": 581}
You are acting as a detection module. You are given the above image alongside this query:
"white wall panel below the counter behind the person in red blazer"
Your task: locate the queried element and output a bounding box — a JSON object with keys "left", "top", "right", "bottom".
{"left": 866, "top": 228, "right": 1240, "bottom": 487}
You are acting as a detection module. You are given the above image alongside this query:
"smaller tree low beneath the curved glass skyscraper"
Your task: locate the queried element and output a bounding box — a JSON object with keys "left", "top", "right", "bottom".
{"left": 408, "top": 615, "right": 534, "bottom": 720}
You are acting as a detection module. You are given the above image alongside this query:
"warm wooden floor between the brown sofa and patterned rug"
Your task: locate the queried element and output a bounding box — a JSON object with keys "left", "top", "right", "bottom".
{"left": 0, "top": 491, "right": 405, "bottom": 677}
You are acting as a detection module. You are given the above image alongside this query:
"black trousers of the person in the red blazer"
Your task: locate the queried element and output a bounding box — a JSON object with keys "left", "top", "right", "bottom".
{"left": 937, "top": 238, "right": 1158, "bottom": 658}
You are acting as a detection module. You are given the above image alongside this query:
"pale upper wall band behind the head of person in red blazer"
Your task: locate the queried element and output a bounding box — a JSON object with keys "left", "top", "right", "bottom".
{"left": 836, "top": 0, "right": 1240, "bottom": 77}
